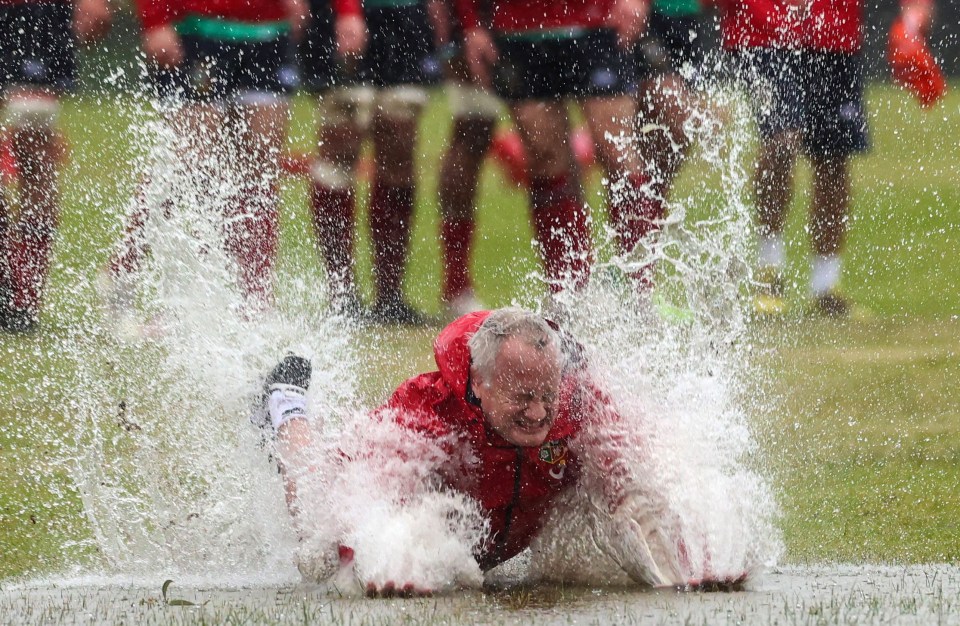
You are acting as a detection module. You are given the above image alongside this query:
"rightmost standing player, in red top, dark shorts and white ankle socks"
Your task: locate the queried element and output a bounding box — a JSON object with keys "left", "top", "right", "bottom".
{"left": 719, "top": 0, "right": 932, "bottom": 316}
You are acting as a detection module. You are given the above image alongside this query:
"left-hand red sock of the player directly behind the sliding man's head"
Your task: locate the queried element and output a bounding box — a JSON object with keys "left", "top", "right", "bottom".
{"left": 530, "top": 176, "right": 592, "bottom": 293}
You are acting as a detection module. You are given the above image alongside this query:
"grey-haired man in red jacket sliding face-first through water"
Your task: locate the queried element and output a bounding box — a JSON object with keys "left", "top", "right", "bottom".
{"left": 253, "top": 308, "right": 746, "bottom": 596}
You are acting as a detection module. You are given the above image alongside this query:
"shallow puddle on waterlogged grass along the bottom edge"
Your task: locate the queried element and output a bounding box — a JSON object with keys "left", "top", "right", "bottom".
{"left": 0, "top": 565, "right": 960, "bottom": 626}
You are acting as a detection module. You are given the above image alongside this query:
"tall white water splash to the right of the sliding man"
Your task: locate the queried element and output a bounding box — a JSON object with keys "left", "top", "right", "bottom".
{"left": 516, "top": 79, "right": 782, "bottom": 584}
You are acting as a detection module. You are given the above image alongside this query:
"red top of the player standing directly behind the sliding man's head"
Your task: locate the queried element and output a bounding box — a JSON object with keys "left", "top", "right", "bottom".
{"left": 454, "top": 0, "right": 613, "bottom": 33}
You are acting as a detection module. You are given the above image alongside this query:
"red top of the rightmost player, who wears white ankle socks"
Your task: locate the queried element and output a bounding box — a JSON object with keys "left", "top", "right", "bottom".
{"left": 720, "top": 0, "right": 863, "bottom": 53}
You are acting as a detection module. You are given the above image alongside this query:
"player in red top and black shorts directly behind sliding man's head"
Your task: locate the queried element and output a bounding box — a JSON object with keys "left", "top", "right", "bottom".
{"left": 455, "top": 0, "right": 650, "bottom": 293}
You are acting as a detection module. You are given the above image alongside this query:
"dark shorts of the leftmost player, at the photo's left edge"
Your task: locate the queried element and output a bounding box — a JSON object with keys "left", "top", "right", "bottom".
{"left": 0, "top": 2, "right": 77, "bottom": 91}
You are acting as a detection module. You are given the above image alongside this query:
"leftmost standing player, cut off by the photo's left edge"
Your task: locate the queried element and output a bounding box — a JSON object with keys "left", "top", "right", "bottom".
{"left": 0, "top": 0, "right": 111, "bottom": 332}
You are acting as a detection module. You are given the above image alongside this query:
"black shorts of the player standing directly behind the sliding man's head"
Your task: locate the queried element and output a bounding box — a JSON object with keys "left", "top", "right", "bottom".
{"left": 493, "top": 29, "right": 630, "bottom": 102}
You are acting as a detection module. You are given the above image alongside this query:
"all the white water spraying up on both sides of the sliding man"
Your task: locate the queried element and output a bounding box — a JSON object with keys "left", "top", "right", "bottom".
{"left": 7, "top": 73, "right": 779, "bottom": 588}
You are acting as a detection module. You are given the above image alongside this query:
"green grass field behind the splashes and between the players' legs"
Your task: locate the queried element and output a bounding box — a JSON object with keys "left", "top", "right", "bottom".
{"left": 0, "top": 85, "right": 960, "bottom": 581}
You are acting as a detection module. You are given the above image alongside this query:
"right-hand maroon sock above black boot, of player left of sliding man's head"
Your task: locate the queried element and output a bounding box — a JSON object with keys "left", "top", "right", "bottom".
{"left": 369, "top": 183, "right": 414, "bottom": 302}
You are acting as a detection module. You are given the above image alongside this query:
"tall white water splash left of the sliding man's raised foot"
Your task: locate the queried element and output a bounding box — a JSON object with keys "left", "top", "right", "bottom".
{"left": 21, "top": 95, "right": 356, "bottom": 583}
